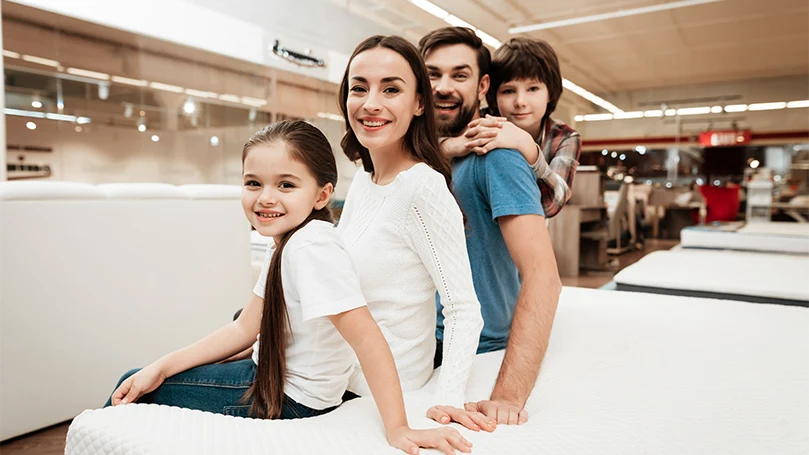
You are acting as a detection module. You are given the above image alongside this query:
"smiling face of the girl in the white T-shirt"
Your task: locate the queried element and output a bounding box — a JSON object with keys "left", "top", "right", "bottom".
{"left": 242, "top": 140, "right": 334, "bottom": 244}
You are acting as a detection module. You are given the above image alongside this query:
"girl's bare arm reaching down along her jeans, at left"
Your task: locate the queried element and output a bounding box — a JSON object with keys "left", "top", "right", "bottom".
{"left": 112, "top": 295, "right": 264, "bottom": 406}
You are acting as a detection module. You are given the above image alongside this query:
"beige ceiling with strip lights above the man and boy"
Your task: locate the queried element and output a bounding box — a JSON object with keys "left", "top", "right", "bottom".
{"left": 333, "top": 0, "right": 809, "bottom": 97}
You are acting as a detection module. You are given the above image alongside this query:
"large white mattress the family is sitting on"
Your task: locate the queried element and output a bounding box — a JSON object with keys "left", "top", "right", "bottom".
{"left": 65, "top": 288, "right": 809, "bottom": 455}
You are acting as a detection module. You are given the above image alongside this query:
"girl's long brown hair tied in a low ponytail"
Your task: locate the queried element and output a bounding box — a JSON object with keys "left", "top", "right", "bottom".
{"left": 242, "top": 120, "right": 337, "bottom": 419}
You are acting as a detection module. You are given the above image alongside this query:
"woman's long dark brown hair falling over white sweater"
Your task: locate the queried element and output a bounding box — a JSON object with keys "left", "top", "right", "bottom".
{"left": 339, "top": 35, "right": 452, "bottom": 190}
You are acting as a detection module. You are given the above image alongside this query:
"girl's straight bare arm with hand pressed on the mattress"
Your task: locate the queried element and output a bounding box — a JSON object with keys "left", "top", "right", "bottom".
{"left": 329, "top": 307, "right": 472, "bottom": 454}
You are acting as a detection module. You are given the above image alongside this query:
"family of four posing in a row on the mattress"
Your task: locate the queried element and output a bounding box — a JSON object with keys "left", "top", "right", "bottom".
{"left": 107, "top": 27, "right": 580, "bottom": 454}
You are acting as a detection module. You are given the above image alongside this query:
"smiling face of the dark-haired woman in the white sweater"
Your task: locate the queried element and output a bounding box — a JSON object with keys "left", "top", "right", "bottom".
{"left": 346, "top": 47, "right": 424, "bottom": 155}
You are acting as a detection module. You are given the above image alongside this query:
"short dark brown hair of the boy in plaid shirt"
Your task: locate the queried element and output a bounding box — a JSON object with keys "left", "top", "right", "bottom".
{"left": 486, "top": 38, "right": 562, "bottom": 124}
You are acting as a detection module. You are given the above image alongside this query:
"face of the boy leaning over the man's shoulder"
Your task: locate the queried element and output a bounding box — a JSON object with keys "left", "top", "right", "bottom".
{"left": 497, "top": 79, "right": 548, "bottom": 138}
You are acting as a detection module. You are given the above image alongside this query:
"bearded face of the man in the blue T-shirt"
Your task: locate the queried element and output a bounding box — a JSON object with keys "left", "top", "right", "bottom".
{"left": 424, "top": 44, "right": 489, "bottom": 137}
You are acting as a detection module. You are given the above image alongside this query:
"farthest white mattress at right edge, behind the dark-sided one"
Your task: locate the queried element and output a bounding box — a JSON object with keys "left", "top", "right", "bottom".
{"left": 680, "top": 223, "right": 809, "bottom": 254}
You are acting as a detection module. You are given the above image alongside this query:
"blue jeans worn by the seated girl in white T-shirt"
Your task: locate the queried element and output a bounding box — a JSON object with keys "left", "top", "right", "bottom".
{"left": 104, "top": 359, "right": 336, "bottom": 419}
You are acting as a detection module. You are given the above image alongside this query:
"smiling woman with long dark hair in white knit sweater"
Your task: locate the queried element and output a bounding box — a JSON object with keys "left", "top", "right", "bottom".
{"left": 338, "top": 36, "right": 494, "bottom": 431}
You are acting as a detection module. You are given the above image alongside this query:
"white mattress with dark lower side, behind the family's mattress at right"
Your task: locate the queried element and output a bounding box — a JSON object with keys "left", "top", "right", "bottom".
{"left": 614, "top": 248, "right": 809, "bottom": 301}
